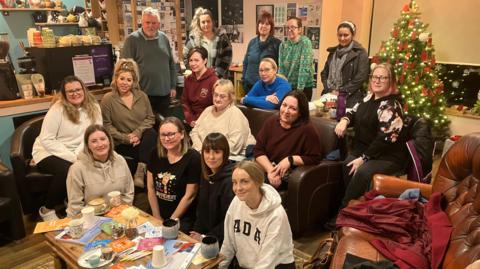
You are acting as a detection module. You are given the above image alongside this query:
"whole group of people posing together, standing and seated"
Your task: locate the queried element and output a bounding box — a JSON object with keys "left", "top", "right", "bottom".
{"left": 32, "top": 5, "right": 412, "bottom": 268}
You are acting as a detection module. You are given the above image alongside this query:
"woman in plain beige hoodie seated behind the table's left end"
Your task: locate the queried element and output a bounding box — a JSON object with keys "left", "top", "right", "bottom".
{"left": 67, "top": 125, "right": 134, "bottom": 217}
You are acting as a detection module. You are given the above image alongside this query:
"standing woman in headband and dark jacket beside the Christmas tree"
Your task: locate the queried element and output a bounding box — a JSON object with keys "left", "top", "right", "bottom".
{"left": 321, "top": 21, "right": 369, "bottom": 119}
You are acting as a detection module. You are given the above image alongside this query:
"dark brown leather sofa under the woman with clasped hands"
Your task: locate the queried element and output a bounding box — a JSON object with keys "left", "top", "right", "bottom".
{"left": 238, "top": 105, "right": 342, "bottom": 237}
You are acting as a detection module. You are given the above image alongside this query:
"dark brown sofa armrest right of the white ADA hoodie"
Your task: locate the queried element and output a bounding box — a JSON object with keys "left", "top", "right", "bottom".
{"left": 287, "top": 161, "right": 342, "bottom": 235}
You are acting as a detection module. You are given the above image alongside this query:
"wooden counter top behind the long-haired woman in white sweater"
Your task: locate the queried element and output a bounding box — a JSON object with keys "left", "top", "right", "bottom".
{"left": 0, "top": 88, "right": 112, "bottom": 117}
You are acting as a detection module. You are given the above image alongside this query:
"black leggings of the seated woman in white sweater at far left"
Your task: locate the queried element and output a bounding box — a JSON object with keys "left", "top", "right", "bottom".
{"left": 37, "top": 155, "right": 72, "bottom": 209}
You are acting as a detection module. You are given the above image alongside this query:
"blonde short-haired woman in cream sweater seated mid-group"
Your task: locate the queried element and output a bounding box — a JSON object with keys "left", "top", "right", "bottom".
{"left": 190, "top": 79, "right": 255, "bottom": 160}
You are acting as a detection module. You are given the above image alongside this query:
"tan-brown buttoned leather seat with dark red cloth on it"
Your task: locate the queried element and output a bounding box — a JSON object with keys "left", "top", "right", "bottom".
{"left": 330, "top": 133, "right": 480, "bottom": 269}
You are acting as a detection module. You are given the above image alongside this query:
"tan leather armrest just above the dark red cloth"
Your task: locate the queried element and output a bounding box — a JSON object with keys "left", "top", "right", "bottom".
{"left": 373, "top": 174, "right": 432, "bottom": 199}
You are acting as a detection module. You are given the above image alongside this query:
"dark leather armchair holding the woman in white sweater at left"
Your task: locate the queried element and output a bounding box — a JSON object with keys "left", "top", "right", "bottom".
{"left": 10, "top": 116, "right": 53, "bottom": 214}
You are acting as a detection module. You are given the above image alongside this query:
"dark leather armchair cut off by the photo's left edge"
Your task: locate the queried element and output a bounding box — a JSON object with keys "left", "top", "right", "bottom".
{"left": 0, "top": 162, "right": 25, "bottom": 240}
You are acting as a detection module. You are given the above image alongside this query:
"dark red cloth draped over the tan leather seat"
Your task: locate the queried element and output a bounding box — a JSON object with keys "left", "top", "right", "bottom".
{"left": 337, "top": 191, "right": 452, "bottom": 269}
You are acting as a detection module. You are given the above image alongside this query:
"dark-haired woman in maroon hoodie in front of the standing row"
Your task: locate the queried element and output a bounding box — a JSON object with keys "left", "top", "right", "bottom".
{"left": 182, "top": 47, "right": 218, "bottom": 128}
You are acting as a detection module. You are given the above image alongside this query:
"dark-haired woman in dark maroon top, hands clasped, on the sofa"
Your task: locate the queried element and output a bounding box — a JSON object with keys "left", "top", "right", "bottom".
{"left": 254, "top": 91, "right": 321, "bottom": 189}
